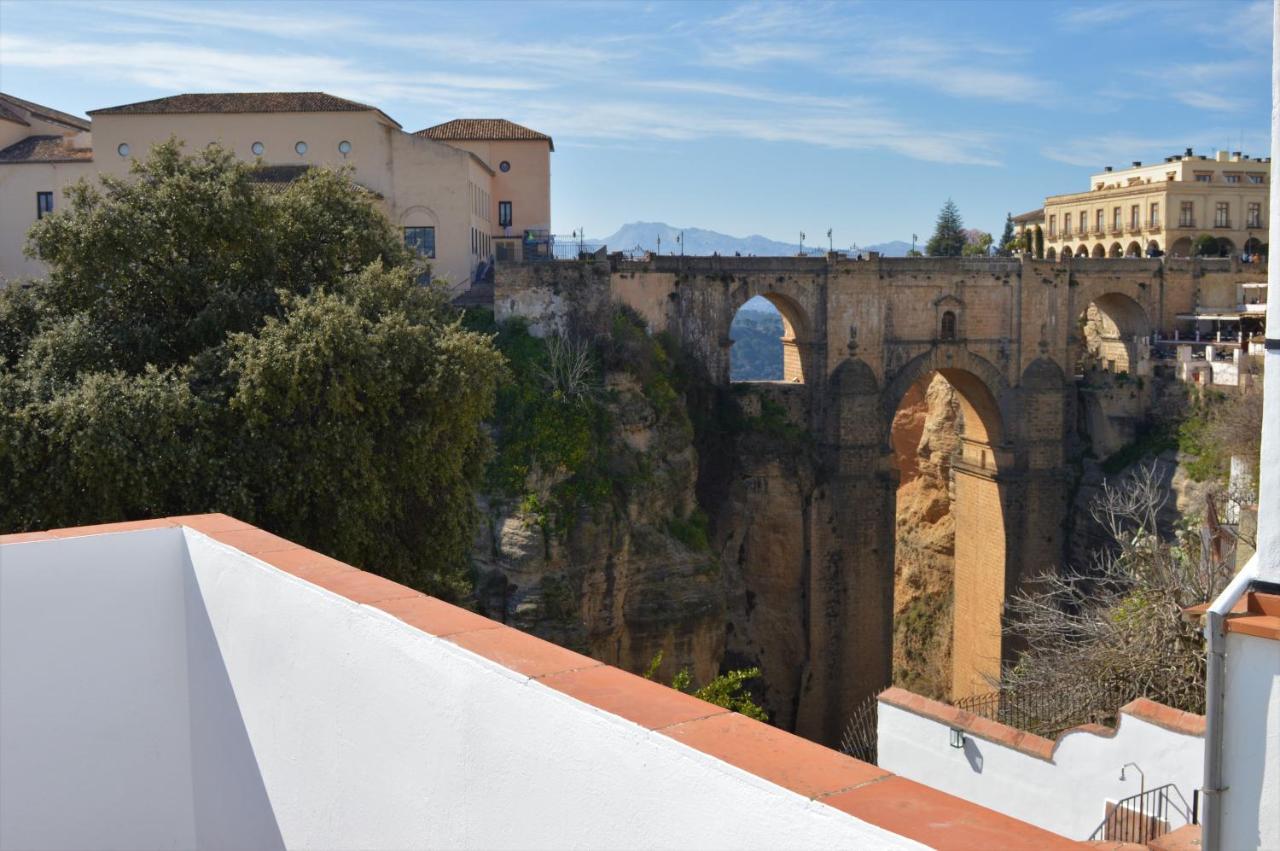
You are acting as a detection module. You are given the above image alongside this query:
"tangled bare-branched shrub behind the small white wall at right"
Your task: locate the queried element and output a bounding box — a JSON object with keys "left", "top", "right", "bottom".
{"left": 1001, "top": 466, "right": 1234, "bottom": 723}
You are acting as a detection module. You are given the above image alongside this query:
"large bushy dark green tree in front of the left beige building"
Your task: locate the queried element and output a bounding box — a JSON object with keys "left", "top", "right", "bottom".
{"left": 0, "top": 141, "right": 504, "bottom": 595}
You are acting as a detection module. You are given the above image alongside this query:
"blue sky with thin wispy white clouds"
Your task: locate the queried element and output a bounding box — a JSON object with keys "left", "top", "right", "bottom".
{"left": 0, "top": 0, "right": 1271, "bottom": 247}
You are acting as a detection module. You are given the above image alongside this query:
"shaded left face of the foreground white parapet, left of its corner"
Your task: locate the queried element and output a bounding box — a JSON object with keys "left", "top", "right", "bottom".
{"left": 0, "top": 530, "right": 196, "bottom": 851}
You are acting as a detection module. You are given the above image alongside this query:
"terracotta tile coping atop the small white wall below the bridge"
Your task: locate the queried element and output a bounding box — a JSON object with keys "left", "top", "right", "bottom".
{"left": 878, "top": 686, "right": 1204, "bottom": 763}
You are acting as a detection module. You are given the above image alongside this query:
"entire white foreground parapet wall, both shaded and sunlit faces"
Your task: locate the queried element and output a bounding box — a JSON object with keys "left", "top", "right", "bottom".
{"left": 0, "top": 529, "right": 922, "bottom": 850}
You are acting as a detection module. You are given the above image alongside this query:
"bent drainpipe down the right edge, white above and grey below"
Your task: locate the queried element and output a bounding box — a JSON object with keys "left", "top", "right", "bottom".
{"left": 1201, "top": 0, "right": 1280, "bottom": 851}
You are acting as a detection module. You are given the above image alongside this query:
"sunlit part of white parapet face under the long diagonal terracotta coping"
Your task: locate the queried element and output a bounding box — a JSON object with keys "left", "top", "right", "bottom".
{"left": 188, "top": 531, "right": 920, "bottom": 848}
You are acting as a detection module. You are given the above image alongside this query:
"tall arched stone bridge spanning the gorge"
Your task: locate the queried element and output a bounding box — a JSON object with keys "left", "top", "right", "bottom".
{"left": 495, "top": 256, "right": 1240, "bottom": 742}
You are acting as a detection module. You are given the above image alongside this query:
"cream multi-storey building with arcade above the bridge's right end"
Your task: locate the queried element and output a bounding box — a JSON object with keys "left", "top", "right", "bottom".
{"left": 1039, "top": 148, "right": 1271, "bottom": 260}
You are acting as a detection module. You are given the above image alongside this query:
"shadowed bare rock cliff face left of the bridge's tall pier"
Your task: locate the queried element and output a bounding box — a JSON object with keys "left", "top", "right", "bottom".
{"left": 472, "top": 371, "right": 726, "bottom": 682}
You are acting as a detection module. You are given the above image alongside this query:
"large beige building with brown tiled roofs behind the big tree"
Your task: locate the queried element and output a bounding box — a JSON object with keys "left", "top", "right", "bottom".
{"left": 0, "top": 92, "right": 554, "bottom": 289}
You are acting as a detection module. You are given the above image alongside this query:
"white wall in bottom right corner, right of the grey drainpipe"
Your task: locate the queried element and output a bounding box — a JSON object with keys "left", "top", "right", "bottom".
{"left": 1221, "top": 632, "right": 1280, "bottom": 851}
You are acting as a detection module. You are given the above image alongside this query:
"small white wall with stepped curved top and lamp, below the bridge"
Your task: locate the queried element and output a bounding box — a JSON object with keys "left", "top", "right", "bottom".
{"left": 877, "top": 703, "right": 1204, "bottom": 839}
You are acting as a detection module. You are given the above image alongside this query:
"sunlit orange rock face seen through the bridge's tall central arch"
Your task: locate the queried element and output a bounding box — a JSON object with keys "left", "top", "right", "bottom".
{"left": 892, "top": 375, "right": 964, "bottom": 699}
